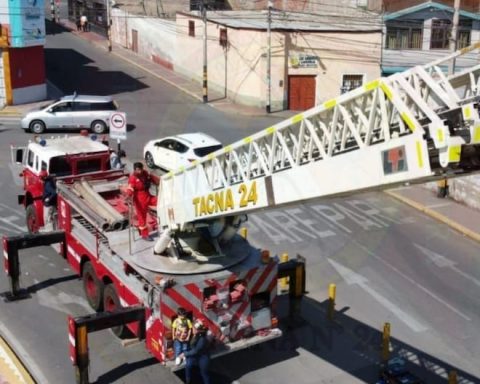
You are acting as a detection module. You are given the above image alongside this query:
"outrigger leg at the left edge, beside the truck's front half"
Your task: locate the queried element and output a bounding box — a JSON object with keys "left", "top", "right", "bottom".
{"left": 3, "top": 231, "right": 67, "bottom": 301}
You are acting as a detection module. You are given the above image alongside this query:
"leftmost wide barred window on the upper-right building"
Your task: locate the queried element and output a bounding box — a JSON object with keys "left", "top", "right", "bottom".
{"left": 385, "top": 22, "right": 423, "bottom": 49}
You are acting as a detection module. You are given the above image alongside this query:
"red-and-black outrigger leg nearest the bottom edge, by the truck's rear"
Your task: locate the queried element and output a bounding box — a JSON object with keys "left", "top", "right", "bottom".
{"left": 68, "top": 306, "right": 145, "bottom": 384}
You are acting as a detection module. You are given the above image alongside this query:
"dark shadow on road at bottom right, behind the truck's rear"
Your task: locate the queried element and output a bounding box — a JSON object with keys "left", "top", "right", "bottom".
{"left": 204, "top": 297, "right": 480, "bottom": 384}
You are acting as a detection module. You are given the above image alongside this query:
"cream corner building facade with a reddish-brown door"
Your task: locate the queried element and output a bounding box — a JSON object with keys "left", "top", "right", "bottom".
{"left": 174, "top": 11, "right": 381, "bottom": 110}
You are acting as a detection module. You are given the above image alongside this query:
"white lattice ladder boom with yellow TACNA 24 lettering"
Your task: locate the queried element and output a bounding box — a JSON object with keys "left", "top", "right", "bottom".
{"left": 158, "top": 42, "right": 480, "bottom": 231}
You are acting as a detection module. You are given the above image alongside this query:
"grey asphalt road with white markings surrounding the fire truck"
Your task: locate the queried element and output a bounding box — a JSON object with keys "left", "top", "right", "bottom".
{"left": 0, "top": 20, "right": 480, "bottom": 384}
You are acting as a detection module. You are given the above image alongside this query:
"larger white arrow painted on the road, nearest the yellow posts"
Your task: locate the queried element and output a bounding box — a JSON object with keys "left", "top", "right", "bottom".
{"left": 328, "top": 259, "right": 428, "bottom": 332}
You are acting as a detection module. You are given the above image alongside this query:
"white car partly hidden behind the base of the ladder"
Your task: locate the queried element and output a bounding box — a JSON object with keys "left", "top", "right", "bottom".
{"left": 143, "top": 133, "right": 222, "bottom": 171}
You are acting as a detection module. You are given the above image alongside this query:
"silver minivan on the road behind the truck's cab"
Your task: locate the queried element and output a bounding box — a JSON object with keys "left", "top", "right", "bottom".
{"left": 21, "top": 94, "right": 118, "bottom": 134}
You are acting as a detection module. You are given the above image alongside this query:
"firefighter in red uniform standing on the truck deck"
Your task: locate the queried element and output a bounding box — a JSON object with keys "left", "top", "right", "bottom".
{"left": 127, "top": 163, "right": 159, "bottom": 241}
